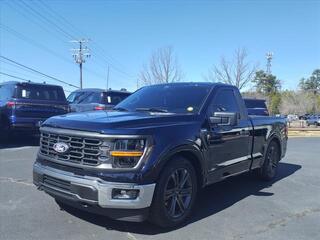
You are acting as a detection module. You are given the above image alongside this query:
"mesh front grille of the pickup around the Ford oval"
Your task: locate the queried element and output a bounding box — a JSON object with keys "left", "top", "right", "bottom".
{"left": 40, "top": 132, "right": 102, "bottom": 166}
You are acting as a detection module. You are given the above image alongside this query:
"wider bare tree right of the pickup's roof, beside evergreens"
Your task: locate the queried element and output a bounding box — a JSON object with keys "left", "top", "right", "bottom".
{"left": 205, "top": 48, "right": 257, "bottom": 89}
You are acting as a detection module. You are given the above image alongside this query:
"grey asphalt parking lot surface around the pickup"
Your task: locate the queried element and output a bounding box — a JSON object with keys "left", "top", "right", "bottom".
{"left": 0, "top": 137, "right": 320, "bottom": 240}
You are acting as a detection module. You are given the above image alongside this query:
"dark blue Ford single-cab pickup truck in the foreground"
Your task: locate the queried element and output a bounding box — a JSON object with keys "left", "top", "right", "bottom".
{"left": 33, "top": 83, "right": 287, "bottom": 227}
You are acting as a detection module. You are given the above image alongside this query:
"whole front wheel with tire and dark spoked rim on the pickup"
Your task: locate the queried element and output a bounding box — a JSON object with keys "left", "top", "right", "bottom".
{"left": 150, "top": 156, "right": 198, "bottom": 227}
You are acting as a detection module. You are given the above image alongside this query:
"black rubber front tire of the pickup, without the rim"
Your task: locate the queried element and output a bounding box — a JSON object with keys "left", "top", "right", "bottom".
{"left": 150, "top": 156, "right": 198, "bottom": 227}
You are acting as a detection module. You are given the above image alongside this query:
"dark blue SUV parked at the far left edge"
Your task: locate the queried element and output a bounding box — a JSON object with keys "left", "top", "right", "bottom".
{"left": 0, "top": 82, "right": 69, "bottom": 138}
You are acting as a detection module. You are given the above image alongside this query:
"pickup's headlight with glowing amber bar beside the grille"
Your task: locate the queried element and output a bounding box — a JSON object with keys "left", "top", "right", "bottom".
{"left": 99, "top": 139, "right": 146, "bottom": 168}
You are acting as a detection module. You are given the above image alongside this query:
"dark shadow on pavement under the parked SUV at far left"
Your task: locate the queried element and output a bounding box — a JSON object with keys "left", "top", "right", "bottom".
{"left": 0, "top": 134, "right": 40, "bottom": 149}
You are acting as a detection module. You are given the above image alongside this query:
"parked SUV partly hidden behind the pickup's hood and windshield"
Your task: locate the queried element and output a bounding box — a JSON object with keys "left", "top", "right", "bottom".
{"left": 67, "top": 88, "right": 131, "bottom": 112}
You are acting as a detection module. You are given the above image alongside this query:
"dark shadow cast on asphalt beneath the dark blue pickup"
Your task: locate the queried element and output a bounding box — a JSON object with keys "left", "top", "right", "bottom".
{"left": 60, "top": 163, "right": 301, "bottom": 235}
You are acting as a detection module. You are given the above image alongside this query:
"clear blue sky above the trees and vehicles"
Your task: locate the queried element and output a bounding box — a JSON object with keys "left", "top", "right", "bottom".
{"left": 0, "top": 0, "right": 320, "bottom": 93}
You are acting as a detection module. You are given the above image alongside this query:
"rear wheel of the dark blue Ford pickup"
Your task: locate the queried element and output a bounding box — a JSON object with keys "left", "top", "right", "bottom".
{"left": 259, "top": 141, "right": 280, "bottom": 181}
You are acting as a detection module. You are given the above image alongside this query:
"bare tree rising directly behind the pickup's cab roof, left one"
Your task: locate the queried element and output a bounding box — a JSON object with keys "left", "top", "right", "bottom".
{"left": 138, "top": 47, "right": 183, "bottom": 85}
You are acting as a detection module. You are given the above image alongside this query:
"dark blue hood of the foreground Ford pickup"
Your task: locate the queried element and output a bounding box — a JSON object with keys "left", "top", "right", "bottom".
{"left": 42, "top": 111, "right": 200, "bottom": 134}
